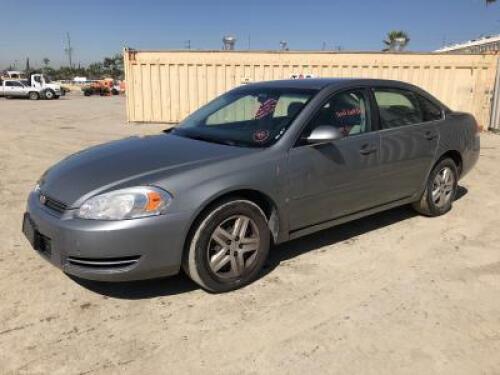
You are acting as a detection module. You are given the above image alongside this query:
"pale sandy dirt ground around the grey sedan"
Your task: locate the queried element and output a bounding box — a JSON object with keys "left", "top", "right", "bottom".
{"left": 0, "top": 96, "right": 500, "bottom": 375}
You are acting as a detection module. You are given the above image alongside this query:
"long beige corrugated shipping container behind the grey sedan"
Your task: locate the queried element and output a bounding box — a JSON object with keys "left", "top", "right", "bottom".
{"left": 124, "top": 50, "right": 497, "bottom": 128}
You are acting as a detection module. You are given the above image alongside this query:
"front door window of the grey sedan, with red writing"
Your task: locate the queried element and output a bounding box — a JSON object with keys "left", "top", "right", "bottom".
{"left": 301, "top": 90, "right": 370, "bottom": 140}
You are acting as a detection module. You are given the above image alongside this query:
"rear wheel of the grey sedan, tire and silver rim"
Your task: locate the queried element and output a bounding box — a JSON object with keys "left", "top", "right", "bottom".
{"left": 413, "top": 158, "right": 458, "bottom": 217}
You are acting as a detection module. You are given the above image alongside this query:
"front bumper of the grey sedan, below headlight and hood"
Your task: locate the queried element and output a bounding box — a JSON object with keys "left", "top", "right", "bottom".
{"left": 23, "top": 192, "right": 190, "bottom": 281}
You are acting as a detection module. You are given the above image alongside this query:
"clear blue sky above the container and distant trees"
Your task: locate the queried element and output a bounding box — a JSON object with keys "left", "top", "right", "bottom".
{"left": 0, "top": 0, "right": 500, "bottom": 68}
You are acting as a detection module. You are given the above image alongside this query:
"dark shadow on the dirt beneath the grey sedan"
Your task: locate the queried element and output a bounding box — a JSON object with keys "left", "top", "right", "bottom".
{"left": 67, "top": 186, "right": 468, "bottom": 300}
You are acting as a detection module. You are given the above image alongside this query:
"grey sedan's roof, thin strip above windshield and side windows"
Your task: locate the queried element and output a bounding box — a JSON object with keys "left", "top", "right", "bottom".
{"left": 239, "top": 78, "right": 415, "bottom": 90}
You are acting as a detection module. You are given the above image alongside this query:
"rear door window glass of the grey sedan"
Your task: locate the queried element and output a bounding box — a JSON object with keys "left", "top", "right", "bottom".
{"left": 374, "top": 89, "right": 424, "bottom": 129}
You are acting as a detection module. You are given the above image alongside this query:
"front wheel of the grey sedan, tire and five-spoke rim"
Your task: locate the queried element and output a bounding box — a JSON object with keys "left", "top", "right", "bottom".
{"left": 183, "top": 199, "right": 270, "bottom": 293}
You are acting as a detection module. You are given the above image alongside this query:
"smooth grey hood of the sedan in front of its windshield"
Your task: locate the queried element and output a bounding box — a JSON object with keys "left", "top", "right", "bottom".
{"left": 39, "top": 134, "right": 255, "bottom": 207}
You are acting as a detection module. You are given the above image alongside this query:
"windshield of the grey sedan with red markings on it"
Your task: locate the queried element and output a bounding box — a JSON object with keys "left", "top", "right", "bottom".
{"left": 172, "top": 88, "right": 317, "bottom": 147}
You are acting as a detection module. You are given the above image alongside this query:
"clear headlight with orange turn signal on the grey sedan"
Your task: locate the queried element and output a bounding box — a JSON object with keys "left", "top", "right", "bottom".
{"left": 76, "top": 186, "right": 172, "bottom": 220}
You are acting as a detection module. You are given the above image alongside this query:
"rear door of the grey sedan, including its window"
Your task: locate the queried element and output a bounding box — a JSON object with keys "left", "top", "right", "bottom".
{"left": 373, "top": 88, "right": 442, "bottom": 202}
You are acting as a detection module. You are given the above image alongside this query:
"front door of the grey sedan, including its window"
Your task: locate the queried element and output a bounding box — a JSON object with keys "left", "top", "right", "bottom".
{"left": 288, "top": 89, "right": 383, "bottom": 231}
